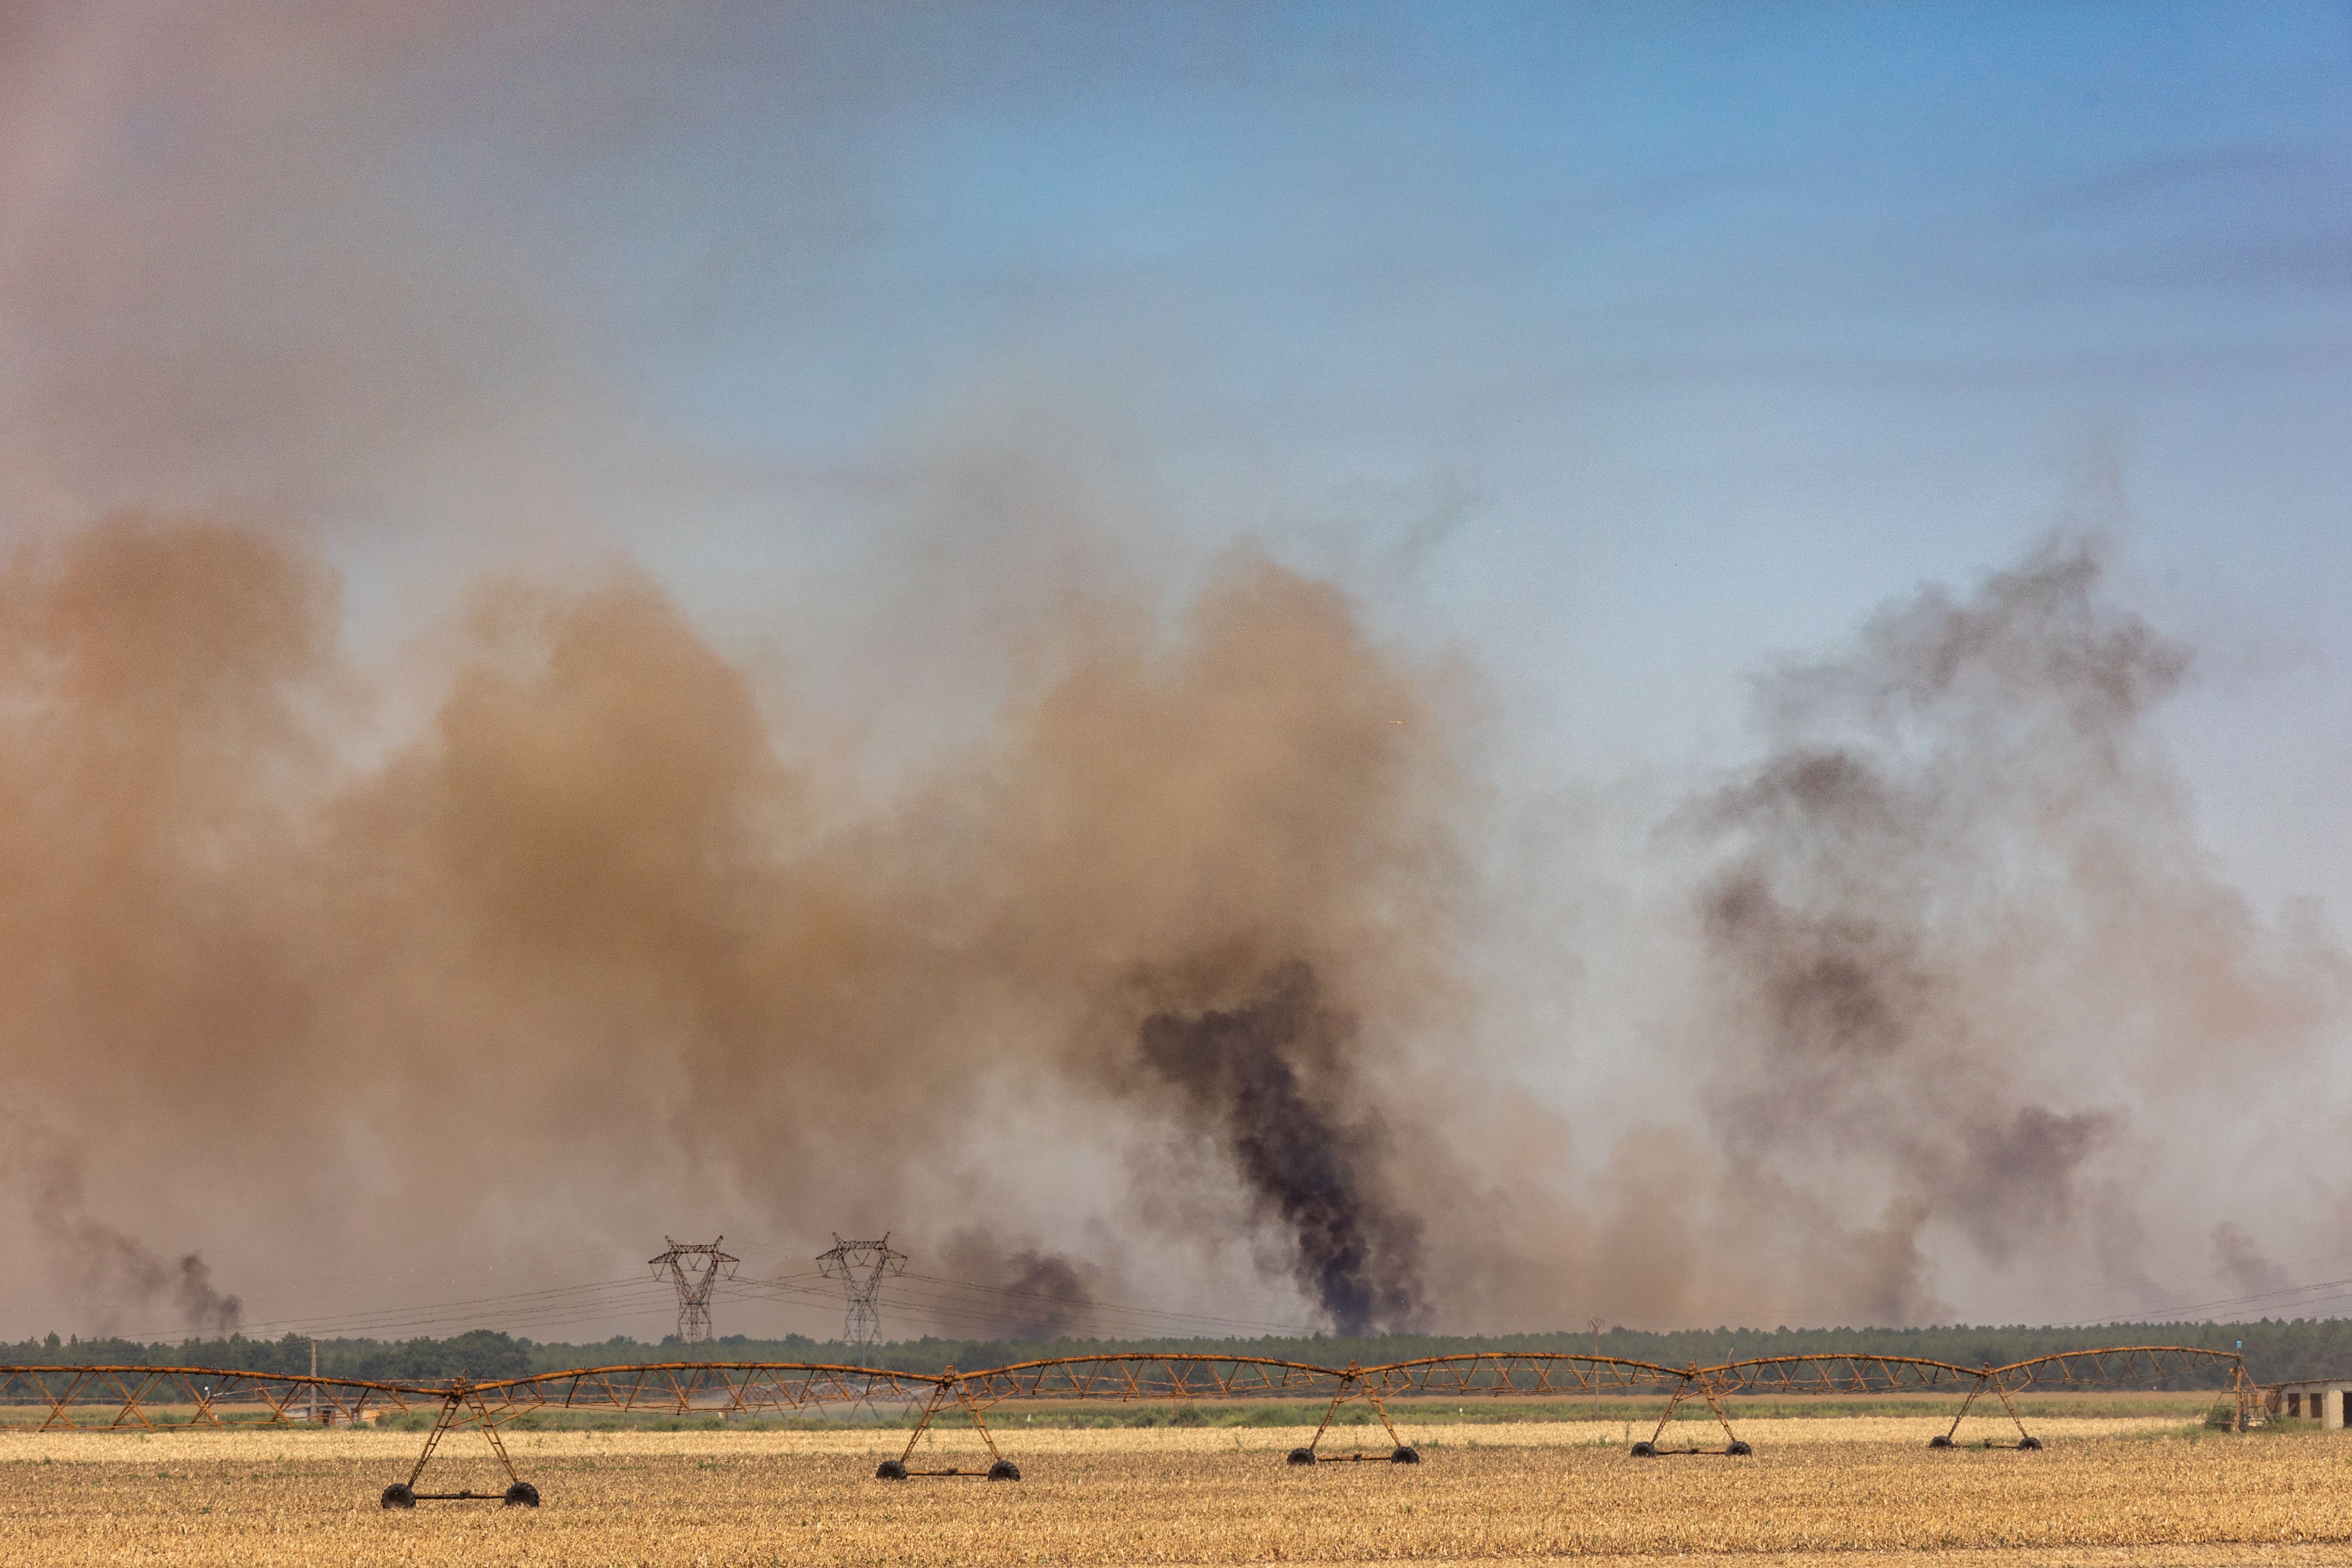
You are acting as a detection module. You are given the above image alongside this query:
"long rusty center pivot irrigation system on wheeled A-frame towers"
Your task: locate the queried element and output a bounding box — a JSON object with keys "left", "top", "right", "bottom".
{"left": 0, "top": 1345, "right": 2263, "bottom": 1509}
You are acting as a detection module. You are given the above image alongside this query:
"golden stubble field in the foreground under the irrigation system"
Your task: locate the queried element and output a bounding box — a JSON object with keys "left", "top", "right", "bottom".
{"left": 0, "top": 1418, "right": 2352, "bottom": 1568}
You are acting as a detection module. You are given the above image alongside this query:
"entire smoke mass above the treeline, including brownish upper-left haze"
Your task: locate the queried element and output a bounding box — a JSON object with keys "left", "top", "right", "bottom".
{"left": 0, "top": 5, "right": 2352, "bottom": 1338}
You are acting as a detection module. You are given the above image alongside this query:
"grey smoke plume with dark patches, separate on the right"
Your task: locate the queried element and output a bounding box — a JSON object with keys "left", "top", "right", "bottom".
{"left": 1698, "top": 546, "right": 2317, "bottom": 1321}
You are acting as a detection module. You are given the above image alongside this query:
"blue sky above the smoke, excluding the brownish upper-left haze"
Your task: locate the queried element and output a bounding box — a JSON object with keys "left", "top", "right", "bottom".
{"left": 487, "top": 5, "right": 2352, "bottom": 891}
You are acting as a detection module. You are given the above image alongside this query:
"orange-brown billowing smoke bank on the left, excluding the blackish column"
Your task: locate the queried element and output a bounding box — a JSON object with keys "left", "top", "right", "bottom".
{"left": 0, "top": 517, "right": 1456, "bottom": 1328}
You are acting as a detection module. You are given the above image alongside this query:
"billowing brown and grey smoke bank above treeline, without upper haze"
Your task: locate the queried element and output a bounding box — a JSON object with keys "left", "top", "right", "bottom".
{"left": 0, "top": 515, "right": 2340, "bottom": 1331}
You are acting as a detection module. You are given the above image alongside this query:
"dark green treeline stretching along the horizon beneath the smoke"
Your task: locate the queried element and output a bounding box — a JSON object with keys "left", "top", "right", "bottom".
{"left": 0, "top": 1319, "right": 2352, "bottom": 1387}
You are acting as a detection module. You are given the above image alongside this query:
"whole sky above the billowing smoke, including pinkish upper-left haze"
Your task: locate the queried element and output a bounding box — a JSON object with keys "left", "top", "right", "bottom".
{"left": 0, "top": 2, "right": 2352, "bottom": 1333}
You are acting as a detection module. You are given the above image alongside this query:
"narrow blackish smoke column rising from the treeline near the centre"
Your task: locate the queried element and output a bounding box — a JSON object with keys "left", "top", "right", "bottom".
{"left": 1143, "top": 961, "right": 1420, "bottom": 1333}
